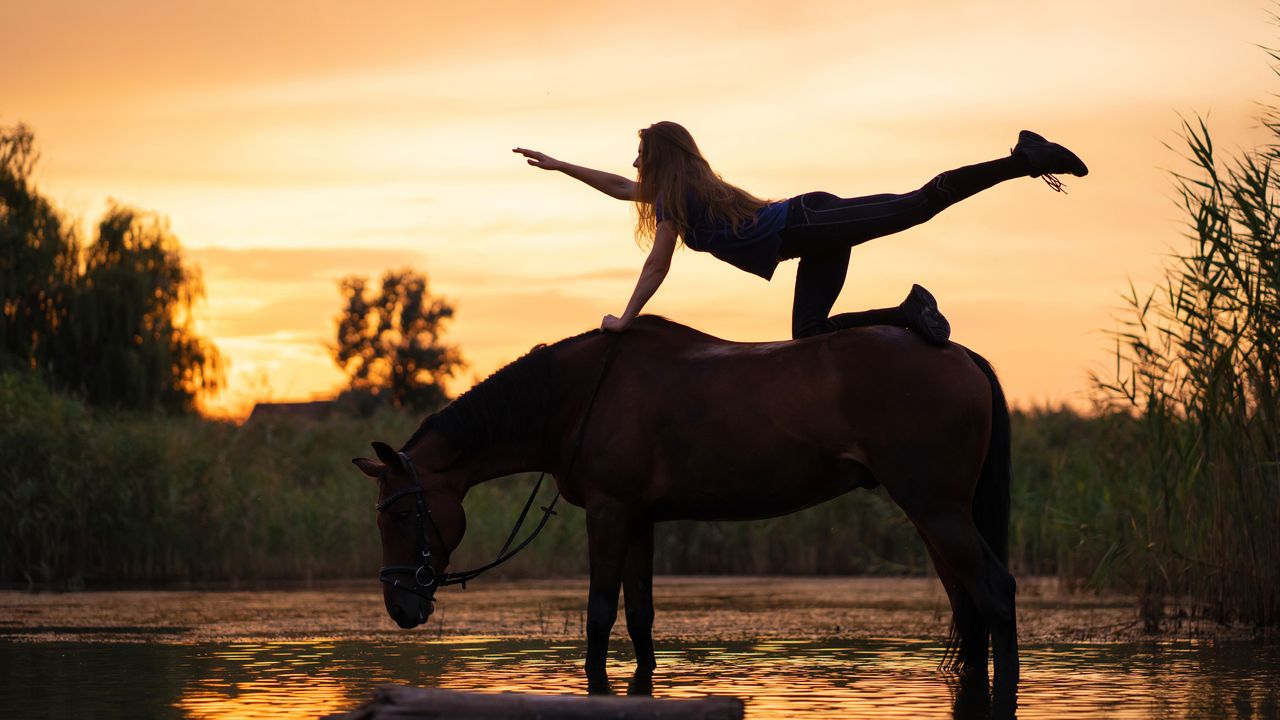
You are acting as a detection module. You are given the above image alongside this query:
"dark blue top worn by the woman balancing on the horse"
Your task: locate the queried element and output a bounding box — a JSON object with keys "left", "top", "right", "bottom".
{"left": 654, "top": 199, "right": 790, "bottom": 279}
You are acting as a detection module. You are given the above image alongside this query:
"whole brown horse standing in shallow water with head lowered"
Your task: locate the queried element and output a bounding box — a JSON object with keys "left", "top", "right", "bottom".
{"left": 353, "top": 316, "right": 1018, "bottom": 694}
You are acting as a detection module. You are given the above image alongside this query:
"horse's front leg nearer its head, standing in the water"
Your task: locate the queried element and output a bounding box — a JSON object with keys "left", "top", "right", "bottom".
{"left": 586, "top": 502, "right": 631, "bottom": 694}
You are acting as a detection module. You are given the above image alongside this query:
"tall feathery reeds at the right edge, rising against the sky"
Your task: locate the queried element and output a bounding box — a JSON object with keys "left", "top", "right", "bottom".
{"left": 1096, "top": 110, "right": 1280, "bottom": 625}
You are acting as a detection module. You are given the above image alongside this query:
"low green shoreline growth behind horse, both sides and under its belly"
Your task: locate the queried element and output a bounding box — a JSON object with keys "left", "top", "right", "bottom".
{"left": 0, "top": 372, "right": 1265, "bottom": 634}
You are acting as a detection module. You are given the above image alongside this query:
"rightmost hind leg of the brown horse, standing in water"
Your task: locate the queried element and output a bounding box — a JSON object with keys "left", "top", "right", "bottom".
{"left": 911, "top": 505, "right": 1018, "bottom": 694}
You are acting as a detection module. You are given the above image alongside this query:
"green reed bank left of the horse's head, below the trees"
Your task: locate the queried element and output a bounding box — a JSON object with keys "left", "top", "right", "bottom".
{"left": 0, "top": 373, "right": 399, "bottom": 587}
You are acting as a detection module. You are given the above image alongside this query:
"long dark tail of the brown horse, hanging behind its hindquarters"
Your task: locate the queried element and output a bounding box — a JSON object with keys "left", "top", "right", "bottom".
{"left": 942, "top": 350, "right": 1012, "bottom": 671}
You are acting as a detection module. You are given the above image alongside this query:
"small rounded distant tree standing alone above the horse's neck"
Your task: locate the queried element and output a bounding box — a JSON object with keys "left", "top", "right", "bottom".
{"left": 332, "top": 269, "right": 466, "bottom": 411}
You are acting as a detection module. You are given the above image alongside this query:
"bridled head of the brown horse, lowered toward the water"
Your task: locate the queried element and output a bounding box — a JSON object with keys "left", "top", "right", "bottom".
{"left": 352, "top": 442, "right": 467, "bottom": 628}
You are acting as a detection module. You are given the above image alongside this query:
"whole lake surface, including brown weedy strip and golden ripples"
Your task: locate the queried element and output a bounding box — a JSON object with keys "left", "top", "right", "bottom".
{"left": 0, "top": 579, "right": 1280, "bottom": 720}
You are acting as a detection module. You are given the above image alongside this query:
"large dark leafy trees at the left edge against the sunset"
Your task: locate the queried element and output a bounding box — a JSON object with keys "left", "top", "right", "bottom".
{"left": 0, "top": 126, "right": 223, "bottom": 411}
